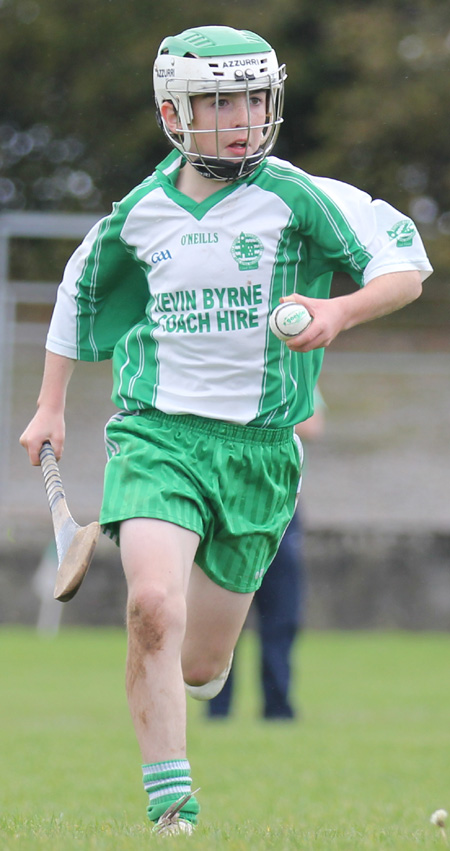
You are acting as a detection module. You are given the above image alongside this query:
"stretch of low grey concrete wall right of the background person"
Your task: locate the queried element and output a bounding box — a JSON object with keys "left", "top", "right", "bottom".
{"left": 305, "top": 529, "right": 450, "bottom": 630}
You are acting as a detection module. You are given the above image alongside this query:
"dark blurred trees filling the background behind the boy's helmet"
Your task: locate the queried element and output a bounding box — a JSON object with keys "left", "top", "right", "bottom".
{"left": 0, "top": 0, "right": 450, "bottom": 324}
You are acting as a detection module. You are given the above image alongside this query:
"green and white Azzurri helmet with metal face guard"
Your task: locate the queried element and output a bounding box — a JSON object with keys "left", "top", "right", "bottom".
{"left": 153, "top": 27, "right": 286, "bottom": 180}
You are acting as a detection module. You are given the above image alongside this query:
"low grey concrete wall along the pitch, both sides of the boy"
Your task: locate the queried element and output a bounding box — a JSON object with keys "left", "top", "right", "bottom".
{"left": 0, "top": 529, "right": 450, "bottom": 630}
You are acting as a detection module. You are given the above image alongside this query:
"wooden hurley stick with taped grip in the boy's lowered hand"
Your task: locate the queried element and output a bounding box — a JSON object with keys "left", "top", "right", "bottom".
{"left": 39, "top": 441, "right": 100, "bottom": 603}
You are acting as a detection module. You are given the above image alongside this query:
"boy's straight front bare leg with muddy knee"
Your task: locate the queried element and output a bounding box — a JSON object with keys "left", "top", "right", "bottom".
{"left": 120, "top": 519, "right": 199, "bottom": 763}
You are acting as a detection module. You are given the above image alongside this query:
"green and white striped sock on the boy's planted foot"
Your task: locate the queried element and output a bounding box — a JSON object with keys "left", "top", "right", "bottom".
{"left": 142, "top": 759, "right": 200, "bottom": 824}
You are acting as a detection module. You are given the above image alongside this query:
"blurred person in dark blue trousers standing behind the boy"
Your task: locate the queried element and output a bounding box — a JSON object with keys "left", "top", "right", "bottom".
{"left": 207, "top": 402, "right": 325, "bottom": 720}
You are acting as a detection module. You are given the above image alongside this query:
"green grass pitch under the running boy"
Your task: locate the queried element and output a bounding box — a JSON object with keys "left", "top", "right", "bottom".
{"left": 0, "top": 629, "right": 450, "bottom": 851}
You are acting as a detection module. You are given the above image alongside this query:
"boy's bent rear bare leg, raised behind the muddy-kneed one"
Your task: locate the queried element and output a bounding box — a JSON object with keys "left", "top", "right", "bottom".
{"left": 181, "top": 564, "right": 253, "bottom": 686}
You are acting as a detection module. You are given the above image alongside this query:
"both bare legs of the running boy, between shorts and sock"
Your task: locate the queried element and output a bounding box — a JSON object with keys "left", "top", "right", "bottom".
{"left": 120, "top": 518, "right": 253, "bottom": 763}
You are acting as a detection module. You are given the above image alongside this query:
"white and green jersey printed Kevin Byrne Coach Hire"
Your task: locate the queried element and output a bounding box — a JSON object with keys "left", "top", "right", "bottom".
{"left": 47, "top": 151, "right": 431, "bottom": 427}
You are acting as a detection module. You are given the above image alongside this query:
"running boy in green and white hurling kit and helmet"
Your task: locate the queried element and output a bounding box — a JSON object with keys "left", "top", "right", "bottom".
{"left": 21, "top": 27, "right": 431, "bottom": 833}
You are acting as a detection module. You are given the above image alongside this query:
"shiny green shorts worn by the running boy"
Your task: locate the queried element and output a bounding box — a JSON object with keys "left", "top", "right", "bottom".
{"left": 100, "top": 409, "right": 301, "bottom": 593}
